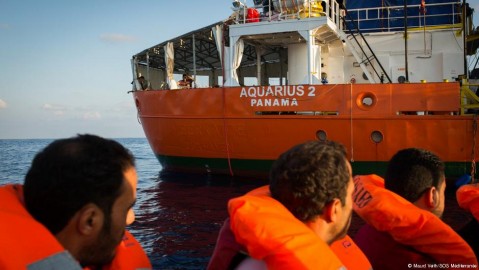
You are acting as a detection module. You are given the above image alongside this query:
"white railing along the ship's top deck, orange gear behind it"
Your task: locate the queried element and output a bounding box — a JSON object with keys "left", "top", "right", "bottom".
{"left": 232, "top": 0, "right": 342, "bottom": 29}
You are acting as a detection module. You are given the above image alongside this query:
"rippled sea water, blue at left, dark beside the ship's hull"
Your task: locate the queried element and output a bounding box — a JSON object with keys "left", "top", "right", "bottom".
{"left": 0, "top": 138, "right": 471, "bottom": 269}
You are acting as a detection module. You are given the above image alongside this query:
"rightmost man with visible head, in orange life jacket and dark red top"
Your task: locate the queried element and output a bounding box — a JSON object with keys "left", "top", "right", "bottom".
{"left": 353, "top": 148, "right": 477, "bottom": 269}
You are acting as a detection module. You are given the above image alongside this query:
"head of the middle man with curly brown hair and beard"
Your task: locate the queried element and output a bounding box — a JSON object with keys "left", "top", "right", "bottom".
{"left": 270, "top": 141, "right": 354, "bottom": 243}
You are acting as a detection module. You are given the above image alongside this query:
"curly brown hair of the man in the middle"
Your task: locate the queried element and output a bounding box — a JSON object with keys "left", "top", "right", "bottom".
{"left": 270, "top": 141, "right": 350, "bottom": 222}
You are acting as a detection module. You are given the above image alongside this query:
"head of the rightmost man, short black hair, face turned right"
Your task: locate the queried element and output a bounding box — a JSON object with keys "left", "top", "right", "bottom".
{"left": 384, "top": 148, "right": 446, "bottom": 217}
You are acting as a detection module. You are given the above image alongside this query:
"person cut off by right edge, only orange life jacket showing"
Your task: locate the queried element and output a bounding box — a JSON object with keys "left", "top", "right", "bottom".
{"left": 456, "top": 183, "right": 479, "bottom": 257}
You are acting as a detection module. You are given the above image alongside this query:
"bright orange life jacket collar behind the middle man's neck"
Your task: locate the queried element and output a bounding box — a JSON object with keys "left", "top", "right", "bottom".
{"left": 228, "top": 186, "right": 344, "bottom": 269}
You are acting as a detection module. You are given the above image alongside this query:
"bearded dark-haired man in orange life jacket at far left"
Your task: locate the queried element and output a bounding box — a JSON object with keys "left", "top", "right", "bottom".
{"left": 0, "top": 135, "right": 151, "bottom": 269}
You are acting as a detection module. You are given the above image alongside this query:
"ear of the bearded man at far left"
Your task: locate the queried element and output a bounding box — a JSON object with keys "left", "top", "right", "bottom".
{"left": 77, "top": 203, "right": 104, "bottom": 235}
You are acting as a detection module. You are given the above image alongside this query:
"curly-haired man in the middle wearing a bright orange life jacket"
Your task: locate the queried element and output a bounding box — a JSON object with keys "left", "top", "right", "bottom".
{"left": 208, "top": 141, "right": 368, "bottom": 270}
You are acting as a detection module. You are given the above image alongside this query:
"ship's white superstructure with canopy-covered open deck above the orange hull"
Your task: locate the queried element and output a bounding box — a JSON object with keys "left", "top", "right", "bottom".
{"left": 132, "top": 0, "right": 343, "bottom": 89}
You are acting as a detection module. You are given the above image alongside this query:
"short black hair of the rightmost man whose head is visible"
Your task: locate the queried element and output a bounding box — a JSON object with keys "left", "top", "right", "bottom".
{"left": 384, "top": 148, "right": 444, "bottom": 202}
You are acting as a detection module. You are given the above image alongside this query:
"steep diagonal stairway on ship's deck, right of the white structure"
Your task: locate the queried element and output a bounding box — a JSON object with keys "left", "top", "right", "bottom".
{"left": 339, "top": 4, "right": 392, "bottom": 83}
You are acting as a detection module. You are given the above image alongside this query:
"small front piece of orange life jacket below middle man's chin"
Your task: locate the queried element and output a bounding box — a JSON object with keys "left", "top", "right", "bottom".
{"left": 331, "top": 235, "right": 373, "bottom": 270}
